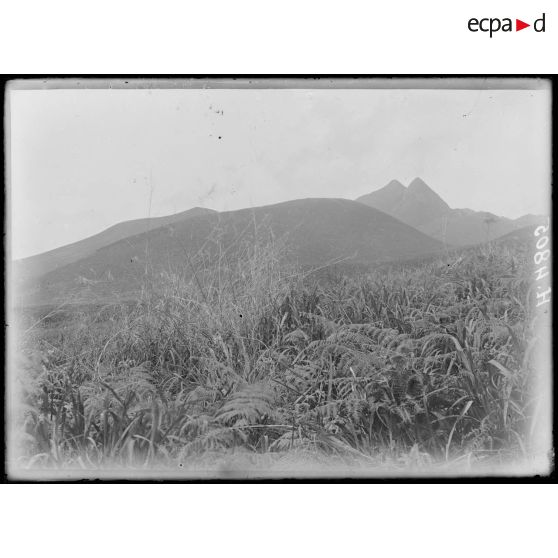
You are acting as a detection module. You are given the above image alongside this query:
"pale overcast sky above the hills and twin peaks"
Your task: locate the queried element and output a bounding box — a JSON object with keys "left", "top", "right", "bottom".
{"left": 10, "top": 84, "right": 550, "bottom": 258}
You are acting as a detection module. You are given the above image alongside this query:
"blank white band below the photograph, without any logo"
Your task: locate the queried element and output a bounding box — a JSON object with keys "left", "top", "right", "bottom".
{"left": 0, "top": 484, "right": 556, "bottom": 558}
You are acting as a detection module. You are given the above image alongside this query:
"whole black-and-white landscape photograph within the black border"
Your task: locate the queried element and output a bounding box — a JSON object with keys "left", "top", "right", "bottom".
{"left": 4, "top": 77, "right": 554, "bottom": 481}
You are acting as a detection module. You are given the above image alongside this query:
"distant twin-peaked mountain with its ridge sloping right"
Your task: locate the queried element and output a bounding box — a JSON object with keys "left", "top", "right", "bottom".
{"left": 357, "top": 178, "right": 541, "bottom": 246}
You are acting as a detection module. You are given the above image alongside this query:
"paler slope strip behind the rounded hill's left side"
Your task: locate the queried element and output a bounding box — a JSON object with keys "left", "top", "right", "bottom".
{"left": 14, "top": 207, "right": 215, "bottom": 281}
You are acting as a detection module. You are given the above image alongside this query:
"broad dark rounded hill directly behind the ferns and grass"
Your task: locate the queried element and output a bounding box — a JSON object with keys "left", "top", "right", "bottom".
{"left": 16, "top": 199, "right": 443, "bottom": 303}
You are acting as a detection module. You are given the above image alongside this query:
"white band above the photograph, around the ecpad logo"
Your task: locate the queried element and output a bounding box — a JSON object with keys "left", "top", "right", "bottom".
{"left": 0, "top": 0, "right": 558, "bottom": 74}
